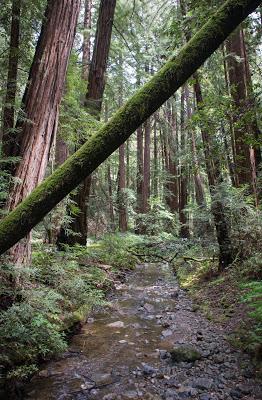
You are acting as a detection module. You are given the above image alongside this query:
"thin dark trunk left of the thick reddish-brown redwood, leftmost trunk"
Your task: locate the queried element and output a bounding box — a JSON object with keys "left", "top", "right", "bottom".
{"left": 2, "top": 0, "right": 21, "bottom": 157}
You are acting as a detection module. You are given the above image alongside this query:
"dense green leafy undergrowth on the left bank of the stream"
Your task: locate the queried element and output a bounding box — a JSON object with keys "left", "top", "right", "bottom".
{"left": 0, "top": 235, "right": 138, "bottom": 379}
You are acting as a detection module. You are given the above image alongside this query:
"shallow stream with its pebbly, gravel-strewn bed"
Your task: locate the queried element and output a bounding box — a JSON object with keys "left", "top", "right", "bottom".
{"left": 25, "top": 264, "right": 262, "bottom": 400}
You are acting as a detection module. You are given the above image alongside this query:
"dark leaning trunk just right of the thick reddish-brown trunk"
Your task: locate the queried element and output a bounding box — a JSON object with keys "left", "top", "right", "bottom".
{"left": 61, "top": 0, "right": 116, "bottom": 246}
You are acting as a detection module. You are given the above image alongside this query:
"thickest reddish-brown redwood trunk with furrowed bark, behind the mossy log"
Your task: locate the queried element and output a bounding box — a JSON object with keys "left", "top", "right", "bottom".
{"left": 8, "top": 0, "right": 80, "bottom": 264}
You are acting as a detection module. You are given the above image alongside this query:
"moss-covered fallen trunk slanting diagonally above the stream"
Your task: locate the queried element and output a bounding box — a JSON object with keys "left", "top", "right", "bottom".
{"left": 0, "top": 0, "right": 261, "bottom": 254}
